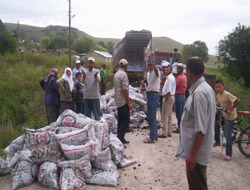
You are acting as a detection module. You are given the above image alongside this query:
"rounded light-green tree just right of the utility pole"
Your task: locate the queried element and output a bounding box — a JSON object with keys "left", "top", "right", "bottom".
{"left": 73, "top": 36, "right": 96, "bottom": 53}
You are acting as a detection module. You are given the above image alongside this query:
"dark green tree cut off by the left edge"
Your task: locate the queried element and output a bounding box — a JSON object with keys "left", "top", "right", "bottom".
{"left": 0, "top": 19, "right": 16, "bottom": 54}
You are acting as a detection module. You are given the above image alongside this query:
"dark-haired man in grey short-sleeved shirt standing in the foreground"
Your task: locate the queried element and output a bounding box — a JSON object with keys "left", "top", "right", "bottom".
{"left": 176, "top": 57, "right": 216, "bottom": 190}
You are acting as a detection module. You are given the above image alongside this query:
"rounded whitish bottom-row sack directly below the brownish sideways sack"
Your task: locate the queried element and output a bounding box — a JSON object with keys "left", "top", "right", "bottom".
{"left": 37, "top": 162, "right": 59, "bottom": 189}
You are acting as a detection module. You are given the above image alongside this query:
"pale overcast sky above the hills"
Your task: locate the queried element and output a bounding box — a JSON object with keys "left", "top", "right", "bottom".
{"left": 0, "top": 0, "right": 250, "bottom": 54}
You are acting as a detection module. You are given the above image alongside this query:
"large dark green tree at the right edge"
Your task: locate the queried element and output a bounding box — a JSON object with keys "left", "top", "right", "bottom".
{"left": 218, "top": 24, "right": 250, "bottom": 87}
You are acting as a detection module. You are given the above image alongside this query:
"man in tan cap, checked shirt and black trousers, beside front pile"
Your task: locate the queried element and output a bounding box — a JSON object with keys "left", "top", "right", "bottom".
{"left": 114, "top": 59, "right": 132, "bottom": 144}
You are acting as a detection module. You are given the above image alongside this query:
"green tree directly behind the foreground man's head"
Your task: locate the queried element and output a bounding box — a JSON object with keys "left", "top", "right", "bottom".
{"left": 182, "top": 41, "right": 208, "bottom": 63}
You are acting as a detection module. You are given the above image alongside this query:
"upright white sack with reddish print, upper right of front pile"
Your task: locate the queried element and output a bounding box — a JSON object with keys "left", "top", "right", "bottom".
{"left": 93, "top": 120, "right": 109, "bottom": 151}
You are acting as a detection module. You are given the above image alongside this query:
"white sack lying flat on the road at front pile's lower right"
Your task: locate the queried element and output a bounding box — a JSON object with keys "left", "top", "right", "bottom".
{"left": 86, "top": 169, "right": 120, "bottom": 186}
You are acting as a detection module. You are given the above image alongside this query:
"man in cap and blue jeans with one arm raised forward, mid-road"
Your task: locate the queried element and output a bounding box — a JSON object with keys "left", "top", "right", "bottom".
{"left": 144, "top": 59, "right": 161, "bottom": 143}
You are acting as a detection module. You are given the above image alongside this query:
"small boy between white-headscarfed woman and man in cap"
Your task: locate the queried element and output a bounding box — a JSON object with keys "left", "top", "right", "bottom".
{"left": 73, "top": 72, "right": 85, "bottom": 113}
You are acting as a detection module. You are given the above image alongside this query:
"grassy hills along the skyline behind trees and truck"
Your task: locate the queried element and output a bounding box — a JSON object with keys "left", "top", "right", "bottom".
{"left": 5, "top": 23, "right": 217, "bottom": 64}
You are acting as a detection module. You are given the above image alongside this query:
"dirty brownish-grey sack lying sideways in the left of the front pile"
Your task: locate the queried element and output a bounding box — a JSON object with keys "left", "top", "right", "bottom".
{"left": 30, "top": 144, "right": 65, "bottom": 164}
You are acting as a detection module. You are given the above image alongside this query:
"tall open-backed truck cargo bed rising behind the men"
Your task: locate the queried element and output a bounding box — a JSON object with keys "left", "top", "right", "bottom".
{"left": 112, "top": 30, "right": 152, "bottom": 86}
